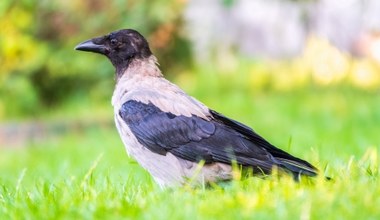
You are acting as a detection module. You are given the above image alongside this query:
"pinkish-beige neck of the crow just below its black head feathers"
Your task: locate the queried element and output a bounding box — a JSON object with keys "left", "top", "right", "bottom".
{"left": 116, "top": 55, "right": 163, "bottom": 81}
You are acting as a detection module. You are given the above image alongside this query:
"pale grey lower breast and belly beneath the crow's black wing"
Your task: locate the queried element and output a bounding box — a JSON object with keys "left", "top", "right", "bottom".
{"left": 115, "top": 111, "right": 232, "bottom": 187}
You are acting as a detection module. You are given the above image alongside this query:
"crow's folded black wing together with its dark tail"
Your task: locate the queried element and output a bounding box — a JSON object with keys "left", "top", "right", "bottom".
{"left": 119, "top": 100, "right": 316, "bottom": 175}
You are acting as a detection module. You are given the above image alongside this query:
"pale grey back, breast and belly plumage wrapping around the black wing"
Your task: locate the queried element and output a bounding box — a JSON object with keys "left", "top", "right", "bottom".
{"left": 112, "top": 75, "right": 231, "bottom": 187}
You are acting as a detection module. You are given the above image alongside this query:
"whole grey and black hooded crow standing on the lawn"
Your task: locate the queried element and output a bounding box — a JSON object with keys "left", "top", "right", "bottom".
{"left": 75, "top": 29, "right": 318, "bottom": 188}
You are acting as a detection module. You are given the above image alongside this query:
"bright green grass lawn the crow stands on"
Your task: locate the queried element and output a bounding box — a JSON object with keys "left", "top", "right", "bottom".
{"left": 0, "top": 84, "right": 380, "bottom": 219}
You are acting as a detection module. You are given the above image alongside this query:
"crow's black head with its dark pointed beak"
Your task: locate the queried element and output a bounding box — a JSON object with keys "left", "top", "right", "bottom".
{"left": 75, "top": 29, "right": 152, "bottom": 72}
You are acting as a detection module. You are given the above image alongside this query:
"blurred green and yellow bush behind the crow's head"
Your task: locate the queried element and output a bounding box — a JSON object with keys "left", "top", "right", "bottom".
{"left": 0, "top": 0, "right": 190, "bottom": 118}
